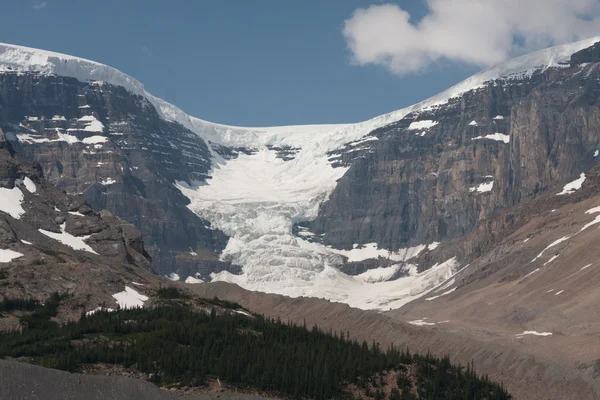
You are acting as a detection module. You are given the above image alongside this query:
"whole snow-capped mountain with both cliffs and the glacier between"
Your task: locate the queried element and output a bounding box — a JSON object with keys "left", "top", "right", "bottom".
{"left": 0, "top": 38, "right": 600, "bottom": 309}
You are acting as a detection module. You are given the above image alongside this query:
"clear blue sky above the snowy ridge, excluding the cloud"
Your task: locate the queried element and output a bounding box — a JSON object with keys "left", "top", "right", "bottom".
{"left": 0, "top": 0, "right": 592, "bottom": 126}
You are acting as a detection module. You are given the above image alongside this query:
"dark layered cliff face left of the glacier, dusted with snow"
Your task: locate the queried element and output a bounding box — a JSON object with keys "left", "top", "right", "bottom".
{"left": 0, "top": 72, "right": 230, "bottom": 276}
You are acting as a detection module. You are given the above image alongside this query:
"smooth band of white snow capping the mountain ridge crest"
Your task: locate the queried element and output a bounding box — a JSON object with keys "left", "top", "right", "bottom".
{"left": 0, "top": 36, "right": 600, "bottom": 152}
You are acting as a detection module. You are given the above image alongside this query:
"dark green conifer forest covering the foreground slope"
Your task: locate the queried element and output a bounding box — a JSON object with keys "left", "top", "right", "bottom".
{"left": 0, "top": 296, "right": 509, "bottom": 400}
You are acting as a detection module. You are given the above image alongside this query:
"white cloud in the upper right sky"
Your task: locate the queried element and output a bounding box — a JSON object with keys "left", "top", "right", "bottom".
{"left": 343, "top": 0, "right": 600, "bottom": 75}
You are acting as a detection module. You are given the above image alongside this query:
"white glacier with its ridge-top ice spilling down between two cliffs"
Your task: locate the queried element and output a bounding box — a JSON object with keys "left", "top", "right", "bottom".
{"left": 0, "top": 37, "right": 600, "bottom": 310}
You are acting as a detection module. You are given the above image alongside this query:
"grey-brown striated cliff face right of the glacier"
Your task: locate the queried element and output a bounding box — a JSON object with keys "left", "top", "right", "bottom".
{"left": 309, "top": 45, "right": 600, "bottom": 256}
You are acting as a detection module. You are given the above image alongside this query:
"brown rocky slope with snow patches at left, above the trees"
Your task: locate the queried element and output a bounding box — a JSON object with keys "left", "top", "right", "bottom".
{"left": 0, "top": 130, "right": 157, "bottom": 329}
